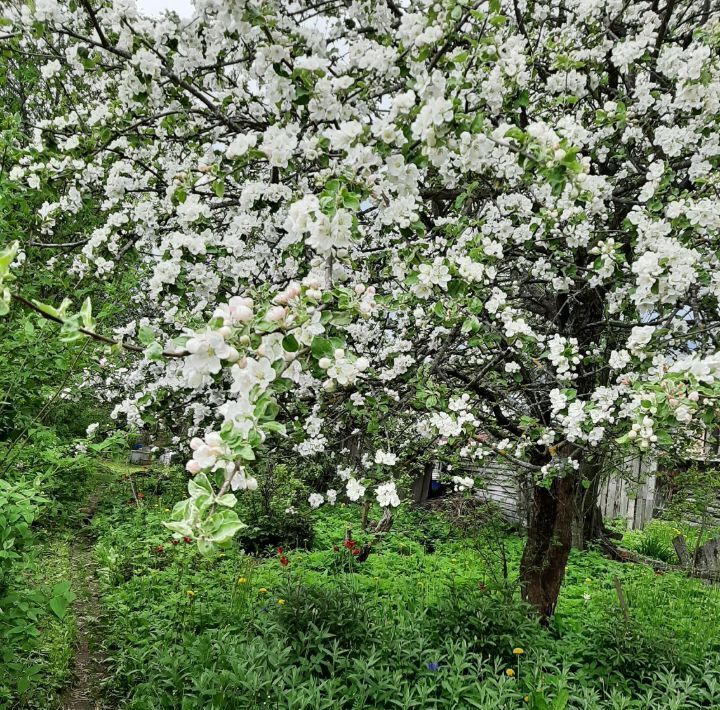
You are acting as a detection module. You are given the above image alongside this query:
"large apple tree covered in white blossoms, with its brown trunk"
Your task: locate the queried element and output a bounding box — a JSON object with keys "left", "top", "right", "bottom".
{"left": 0, "top": 0, "right": 720, "bottom": 616}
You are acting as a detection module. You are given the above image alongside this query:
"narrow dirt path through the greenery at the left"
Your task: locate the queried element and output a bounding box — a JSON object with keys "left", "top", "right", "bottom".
{"left": 62, "top": 484, "right": 107, "bottom": 710}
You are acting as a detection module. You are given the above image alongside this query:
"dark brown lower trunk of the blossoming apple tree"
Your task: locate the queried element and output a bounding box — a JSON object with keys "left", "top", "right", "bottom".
{"left": 520, "top": 475, "right": 578, "bottom": 623}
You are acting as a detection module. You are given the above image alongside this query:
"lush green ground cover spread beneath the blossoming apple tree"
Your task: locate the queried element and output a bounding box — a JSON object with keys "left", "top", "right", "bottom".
{"left": 5, "top": 465, "right": 720, "bottom": 710}
